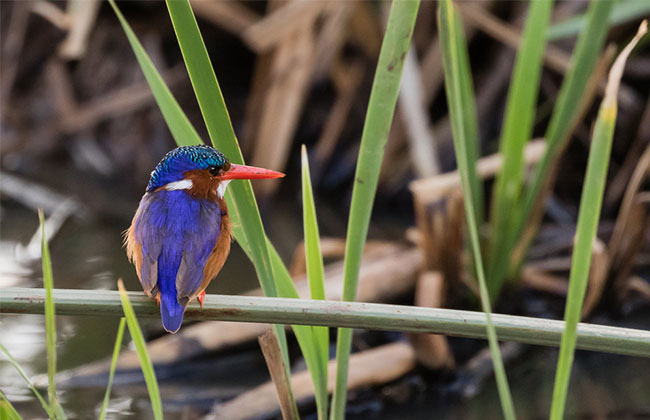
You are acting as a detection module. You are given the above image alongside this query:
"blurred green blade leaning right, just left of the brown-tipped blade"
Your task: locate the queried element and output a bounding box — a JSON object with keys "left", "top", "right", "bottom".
{"left": 511, "top": 0, "right": 613, "bottom": 267}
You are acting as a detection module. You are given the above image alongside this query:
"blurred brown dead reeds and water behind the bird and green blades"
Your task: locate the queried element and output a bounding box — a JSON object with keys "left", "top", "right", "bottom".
{"left": 0, "top": 0, "right": 650, "bottom": 418}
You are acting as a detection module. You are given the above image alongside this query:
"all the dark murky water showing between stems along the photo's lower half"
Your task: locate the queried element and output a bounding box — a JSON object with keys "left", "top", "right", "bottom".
{"left": 0, "top": 202, "right": 650, "bottom": 419}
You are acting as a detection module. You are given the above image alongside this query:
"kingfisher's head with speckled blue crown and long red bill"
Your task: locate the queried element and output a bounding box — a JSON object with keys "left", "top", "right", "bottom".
{"left": 147, "top": 145, "right": 284, "bottom": 198}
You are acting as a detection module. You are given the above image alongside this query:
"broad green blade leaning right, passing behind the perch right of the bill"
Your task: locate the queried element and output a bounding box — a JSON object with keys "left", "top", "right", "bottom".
{"left": 331, "top": 0, "right": 420, "bottom": 419}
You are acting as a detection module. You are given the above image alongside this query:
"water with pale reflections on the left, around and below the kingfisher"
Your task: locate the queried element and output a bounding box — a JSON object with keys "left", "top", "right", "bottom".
{"left": 0, "top": 202, "right": 268, "bottom": 419}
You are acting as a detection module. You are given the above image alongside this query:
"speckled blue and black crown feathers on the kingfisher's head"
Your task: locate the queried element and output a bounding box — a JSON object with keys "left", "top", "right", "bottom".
{"left": 147, "top": 145, "right": 228, "bottom": 191}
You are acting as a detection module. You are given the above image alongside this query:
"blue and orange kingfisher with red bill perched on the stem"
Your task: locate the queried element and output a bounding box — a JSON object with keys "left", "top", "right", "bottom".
{"left": 124, "top": 146, "right": 284, "bottom": 333}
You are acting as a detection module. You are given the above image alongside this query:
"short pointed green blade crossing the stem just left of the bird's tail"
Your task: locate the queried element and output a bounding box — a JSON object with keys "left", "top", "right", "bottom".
{"left": 117, "top": 279, "right": 163, "bottom": 420}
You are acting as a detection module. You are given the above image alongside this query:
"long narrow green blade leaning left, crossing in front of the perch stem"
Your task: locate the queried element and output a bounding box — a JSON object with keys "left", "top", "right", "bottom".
{"left": 438, "top": 0, "right": 515, "bottom": 420}
